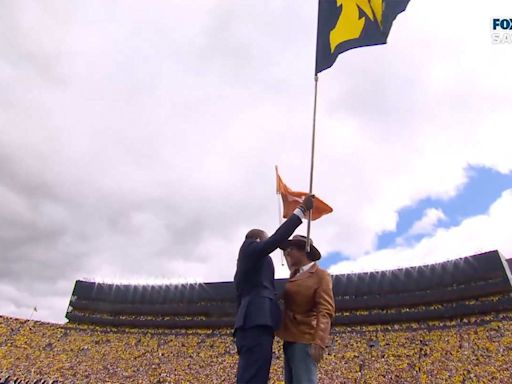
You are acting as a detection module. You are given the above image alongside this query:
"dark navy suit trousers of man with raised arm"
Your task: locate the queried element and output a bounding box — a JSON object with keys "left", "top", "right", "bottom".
{"left": 235, "top": 326, "right": 274, "bottom": 384}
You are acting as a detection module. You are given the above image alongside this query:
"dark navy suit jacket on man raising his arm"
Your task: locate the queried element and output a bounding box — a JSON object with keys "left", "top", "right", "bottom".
{"left": 234, "top": 214, "right": 302, "bottom": 330}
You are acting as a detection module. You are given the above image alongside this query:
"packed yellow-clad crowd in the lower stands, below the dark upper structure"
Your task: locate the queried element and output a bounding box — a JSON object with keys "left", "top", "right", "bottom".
{"left": 0, "top": 313, "right": 512, "bottom": 384}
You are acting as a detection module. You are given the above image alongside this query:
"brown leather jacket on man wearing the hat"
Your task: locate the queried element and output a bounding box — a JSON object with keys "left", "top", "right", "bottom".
{"left": 277, "top": 263, "right": 334, "bottom": 348}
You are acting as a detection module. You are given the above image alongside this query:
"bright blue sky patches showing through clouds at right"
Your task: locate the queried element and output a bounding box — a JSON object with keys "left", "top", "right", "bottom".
{"left": 320, "top": 167, "right": 512, "bottom": 268}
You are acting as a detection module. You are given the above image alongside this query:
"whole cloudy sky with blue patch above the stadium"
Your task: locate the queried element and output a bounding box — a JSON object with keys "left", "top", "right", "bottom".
{"left": 0, "top": 0, "right": 512, "bottom": 322}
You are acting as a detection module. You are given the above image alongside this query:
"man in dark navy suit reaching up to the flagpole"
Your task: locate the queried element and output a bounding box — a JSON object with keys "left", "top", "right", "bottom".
{"left": 234, "top": 195, "right": 314, "bottom": 384}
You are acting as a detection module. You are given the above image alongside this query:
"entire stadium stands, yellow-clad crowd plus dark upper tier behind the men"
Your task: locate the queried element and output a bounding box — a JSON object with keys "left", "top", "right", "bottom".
{"left": 0, "top": 251, "right": 512, "bottom": 384}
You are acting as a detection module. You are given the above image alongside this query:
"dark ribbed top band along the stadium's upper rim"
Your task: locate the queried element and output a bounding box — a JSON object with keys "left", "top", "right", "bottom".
{"left": 72, "top": 251, "right": 505, "bottom": 305}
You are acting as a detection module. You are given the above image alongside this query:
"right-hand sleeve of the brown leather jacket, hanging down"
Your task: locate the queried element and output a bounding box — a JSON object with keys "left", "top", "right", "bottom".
{"left": 313, "top": 272, "right": 335, "bottom": 348}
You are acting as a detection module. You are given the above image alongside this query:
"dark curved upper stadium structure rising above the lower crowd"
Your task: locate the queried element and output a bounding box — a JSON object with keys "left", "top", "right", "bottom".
{"left": 66, "top": 251, "right": 512, "bottom": 328}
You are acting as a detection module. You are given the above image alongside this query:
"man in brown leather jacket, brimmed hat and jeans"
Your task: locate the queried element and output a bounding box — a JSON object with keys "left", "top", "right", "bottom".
{"left": 277, "top": 235, "right": 334, "bottom": 384}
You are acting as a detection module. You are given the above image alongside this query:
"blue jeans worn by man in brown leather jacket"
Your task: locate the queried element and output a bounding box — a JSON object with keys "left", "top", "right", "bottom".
{"left": 283, "top": 341, "right": 318, "bottom": 384}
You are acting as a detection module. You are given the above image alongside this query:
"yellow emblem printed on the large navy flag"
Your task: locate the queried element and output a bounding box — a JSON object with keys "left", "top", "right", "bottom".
{"left": 329, "top": 0, "right": 385, "bottom": 53}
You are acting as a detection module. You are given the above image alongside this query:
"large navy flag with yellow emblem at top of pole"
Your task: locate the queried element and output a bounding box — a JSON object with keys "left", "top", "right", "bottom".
{"left": 315, "top": 0, "right": 409, "bottom": 73}
